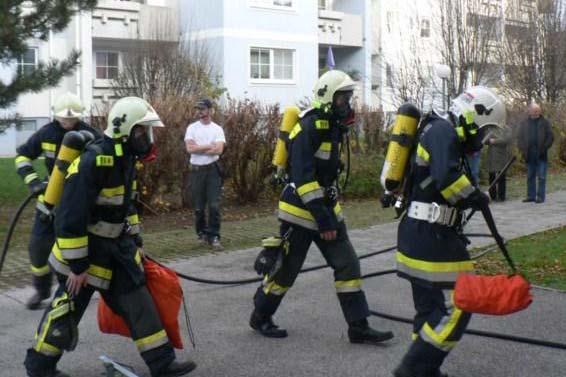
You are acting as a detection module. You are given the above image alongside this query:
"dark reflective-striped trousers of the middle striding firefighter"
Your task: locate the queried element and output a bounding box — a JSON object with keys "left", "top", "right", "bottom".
{"left": 254, "top": 223, "right": 369, "bottom": 323}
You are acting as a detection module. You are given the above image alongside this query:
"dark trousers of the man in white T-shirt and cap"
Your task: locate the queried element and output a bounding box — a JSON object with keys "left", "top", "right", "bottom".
{"left": 190, "top": 164, "right": 222, "bottom": 238}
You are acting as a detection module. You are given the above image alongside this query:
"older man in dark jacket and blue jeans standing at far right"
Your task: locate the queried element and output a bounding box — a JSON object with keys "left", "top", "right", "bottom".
{"left": 518, "top": 103, "right": 554, "bottom": 203}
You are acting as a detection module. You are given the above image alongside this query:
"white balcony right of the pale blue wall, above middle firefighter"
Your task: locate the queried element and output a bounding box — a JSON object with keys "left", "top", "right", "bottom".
{"left": 318, "top": 9, "right": 363, "bottom": 47}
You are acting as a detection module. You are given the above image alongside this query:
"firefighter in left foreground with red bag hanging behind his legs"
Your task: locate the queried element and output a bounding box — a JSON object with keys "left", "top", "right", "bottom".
{"left": 24, "top": 97, "right": 196, "bottom": 377}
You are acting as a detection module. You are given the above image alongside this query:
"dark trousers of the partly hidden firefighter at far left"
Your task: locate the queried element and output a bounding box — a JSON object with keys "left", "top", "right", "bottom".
{"left": 28, "top": 210, "right": 55, "bottom": 296}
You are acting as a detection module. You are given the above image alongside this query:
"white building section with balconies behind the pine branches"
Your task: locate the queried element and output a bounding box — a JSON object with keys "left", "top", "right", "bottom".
{"left": 0, "top": 0, "right": 180, "bottom": 156}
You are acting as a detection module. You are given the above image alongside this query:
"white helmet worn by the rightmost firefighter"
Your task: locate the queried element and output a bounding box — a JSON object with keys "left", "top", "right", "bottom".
{"left": 450, "top": 86, "right": 505, "bottom": 128}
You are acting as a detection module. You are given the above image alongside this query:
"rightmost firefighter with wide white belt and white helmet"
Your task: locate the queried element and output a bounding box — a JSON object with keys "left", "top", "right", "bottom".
{"left": 393, "top": 87, "right": 505, "bottom": 377}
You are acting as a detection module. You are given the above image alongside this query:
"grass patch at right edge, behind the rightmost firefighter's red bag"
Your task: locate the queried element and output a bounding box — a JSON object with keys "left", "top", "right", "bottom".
{"left": 476, "top": 227, "right": 566, "bottom": 290}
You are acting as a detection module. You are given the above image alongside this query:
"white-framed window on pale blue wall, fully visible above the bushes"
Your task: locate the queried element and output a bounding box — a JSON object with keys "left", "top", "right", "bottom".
{"left": 250, "top": 47, "right": 295, "bottom": 81}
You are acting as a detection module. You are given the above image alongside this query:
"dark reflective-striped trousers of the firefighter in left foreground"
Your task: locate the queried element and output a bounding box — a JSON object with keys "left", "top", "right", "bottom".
{"left": 24, "top": 276, "right": 175, "bottom": 377}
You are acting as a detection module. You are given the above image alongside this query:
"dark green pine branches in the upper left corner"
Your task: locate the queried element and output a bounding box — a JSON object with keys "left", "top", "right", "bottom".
{"left": 0, "top": 0, "right": 98, "bottom": 109}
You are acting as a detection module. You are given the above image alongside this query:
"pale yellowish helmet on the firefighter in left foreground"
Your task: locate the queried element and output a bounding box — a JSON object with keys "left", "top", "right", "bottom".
{"left": 104, "top": 97, "right": 164, "bottom": 139}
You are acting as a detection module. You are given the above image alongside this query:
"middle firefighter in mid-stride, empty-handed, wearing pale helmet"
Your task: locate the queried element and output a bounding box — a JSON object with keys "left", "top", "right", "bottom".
{"left": 250, "top": 70, "right": 393, "bottom": 343}
